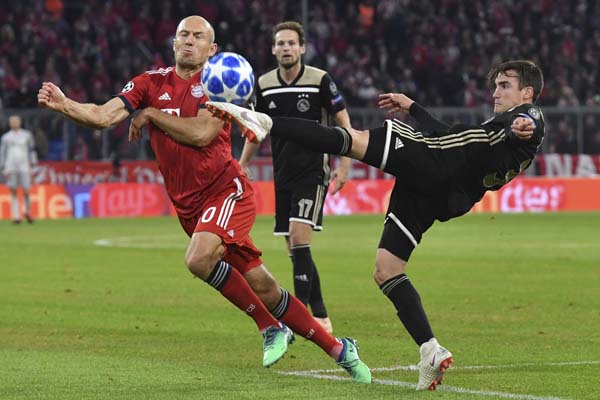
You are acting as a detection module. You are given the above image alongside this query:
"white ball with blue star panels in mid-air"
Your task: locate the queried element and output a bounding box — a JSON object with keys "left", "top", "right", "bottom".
{"left": 202, "top": 52, "right": 254, "bottom": 105}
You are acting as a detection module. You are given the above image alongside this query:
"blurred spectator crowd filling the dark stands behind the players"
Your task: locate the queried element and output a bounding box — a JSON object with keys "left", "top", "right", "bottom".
{"left": 0, "top": 0, "right": 600, "bottom": 157}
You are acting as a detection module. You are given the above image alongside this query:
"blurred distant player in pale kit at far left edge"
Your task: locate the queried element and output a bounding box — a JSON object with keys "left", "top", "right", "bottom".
{"left": 0, "top": 115, "right": 37, "bottom": 224}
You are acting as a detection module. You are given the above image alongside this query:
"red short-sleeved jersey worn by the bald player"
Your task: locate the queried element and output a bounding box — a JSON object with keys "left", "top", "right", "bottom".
{"left": 119, "top": 67, "right": 241, "bottom": 218}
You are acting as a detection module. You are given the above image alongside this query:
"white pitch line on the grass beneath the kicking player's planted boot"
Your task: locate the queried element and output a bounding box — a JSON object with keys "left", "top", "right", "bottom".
{"left": 277, "top": 371, "right": 568, "bottom": 400}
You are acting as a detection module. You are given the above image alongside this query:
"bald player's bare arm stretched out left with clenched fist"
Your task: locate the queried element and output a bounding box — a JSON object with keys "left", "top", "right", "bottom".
{"left": 38, "top": 82, "right": 129, "bottom": 129}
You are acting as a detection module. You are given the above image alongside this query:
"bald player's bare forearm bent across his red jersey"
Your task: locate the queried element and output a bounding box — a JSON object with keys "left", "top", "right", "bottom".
{"left": 129, "top": 107, "right": 223, "bottom": 147}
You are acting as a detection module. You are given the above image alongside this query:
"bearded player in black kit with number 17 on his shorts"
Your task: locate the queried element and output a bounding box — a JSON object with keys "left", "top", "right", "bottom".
{"left": 240, "top": 21, "right": 350, "bottom": 332}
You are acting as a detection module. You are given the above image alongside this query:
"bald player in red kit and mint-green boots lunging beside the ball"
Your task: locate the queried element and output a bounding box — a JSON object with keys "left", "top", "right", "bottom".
{"left": 38, "top": 16, "right": 371, "bottom": 383}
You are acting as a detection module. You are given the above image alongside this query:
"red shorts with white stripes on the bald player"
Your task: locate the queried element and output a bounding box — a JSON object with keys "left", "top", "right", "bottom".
{"left": 179, "top": 175, "right": 262, "bottom": 274}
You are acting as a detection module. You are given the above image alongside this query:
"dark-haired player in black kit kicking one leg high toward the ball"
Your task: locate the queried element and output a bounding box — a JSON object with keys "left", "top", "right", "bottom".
{"left": 207, "top": 60, "right": 544, "bottom": 390}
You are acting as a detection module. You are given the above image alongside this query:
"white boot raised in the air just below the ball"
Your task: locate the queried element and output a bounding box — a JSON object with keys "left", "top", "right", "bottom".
{"left": 206, "top": 101, "right": 273, "bottom": 143}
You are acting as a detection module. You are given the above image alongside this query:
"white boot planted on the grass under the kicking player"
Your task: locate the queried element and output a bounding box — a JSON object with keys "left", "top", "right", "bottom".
{"left": 417, "top": 338, "right": 454, "bottom": 390}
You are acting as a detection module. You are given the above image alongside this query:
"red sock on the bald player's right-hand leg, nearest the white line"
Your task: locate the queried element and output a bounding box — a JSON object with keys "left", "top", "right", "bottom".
{"left": 279, "top": 295, "right": 342, "bottom": 359}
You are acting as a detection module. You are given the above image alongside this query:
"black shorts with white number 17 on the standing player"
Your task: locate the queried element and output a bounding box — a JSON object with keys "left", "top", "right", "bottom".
{"left": 274, "top": 176, "right": 327, "bottom": 236}
